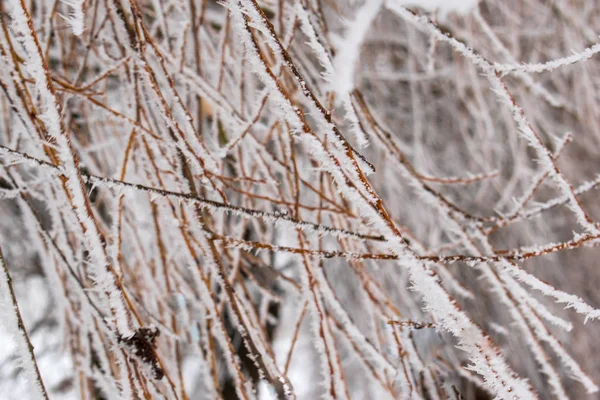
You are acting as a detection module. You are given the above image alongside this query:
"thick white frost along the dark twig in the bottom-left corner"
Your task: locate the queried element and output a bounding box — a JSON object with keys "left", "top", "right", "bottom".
{"left": 0, "top": 255, "right": 47, "bottom": 399}
